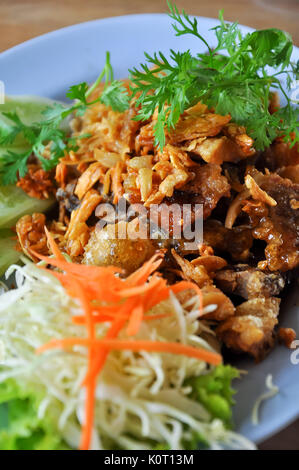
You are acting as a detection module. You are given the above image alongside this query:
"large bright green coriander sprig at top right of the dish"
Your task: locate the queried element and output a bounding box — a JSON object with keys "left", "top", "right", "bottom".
{"left": 130, "top": 2, "right": 299, "bottom": 150}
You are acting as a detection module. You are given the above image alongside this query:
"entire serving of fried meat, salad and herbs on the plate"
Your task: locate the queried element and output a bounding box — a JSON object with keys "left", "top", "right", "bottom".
{"left": 0, "top": 3, "right": 299, "bottom": 449}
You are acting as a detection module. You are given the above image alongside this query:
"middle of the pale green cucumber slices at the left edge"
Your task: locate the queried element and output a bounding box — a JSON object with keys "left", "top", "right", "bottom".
{"left": 0, "top": 185, "right": 55, "bottom": 229}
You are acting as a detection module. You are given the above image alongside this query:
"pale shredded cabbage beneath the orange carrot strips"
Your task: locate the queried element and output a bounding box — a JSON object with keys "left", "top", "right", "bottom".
{"left": 0, "top": 259, "right": 254, "bottom": 450}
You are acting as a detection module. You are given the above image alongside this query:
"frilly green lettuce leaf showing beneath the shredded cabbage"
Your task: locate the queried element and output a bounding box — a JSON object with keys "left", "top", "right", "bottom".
{"left": 0, "top": 365, "right": 239, "bottom": 450}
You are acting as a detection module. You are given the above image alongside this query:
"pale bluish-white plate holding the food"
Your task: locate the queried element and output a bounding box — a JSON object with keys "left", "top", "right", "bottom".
{"left": 0, "top": 14, "right": 299, "bottom": 449}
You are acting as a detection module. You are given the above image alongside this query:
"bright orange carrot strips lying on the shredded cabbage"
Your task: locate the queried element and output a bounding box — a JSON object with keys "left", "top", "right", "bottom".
{"left": 34, "top": 230, "right": 222, "bottom": 449}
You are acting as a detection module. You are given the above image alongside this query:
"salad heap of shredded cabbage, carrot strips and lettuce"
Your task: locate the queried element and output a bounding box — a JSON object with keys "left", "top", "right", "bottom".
{"left": 0, "top": 239, "right": 252, "bottom": 450}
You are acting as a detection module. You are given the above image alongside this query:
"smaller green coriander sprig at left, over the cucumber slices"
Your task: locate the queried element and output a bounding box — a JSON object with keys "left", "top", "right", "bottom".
{"left": 0, "top": 52, "right": 129, "bottom": 184}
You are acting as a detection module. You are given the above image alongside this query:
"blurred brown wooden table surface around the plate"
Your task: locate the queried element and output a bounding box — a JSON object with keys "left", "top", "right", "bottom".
{"left": 0, "top": 0, "right": 299, "bottom": 450}
